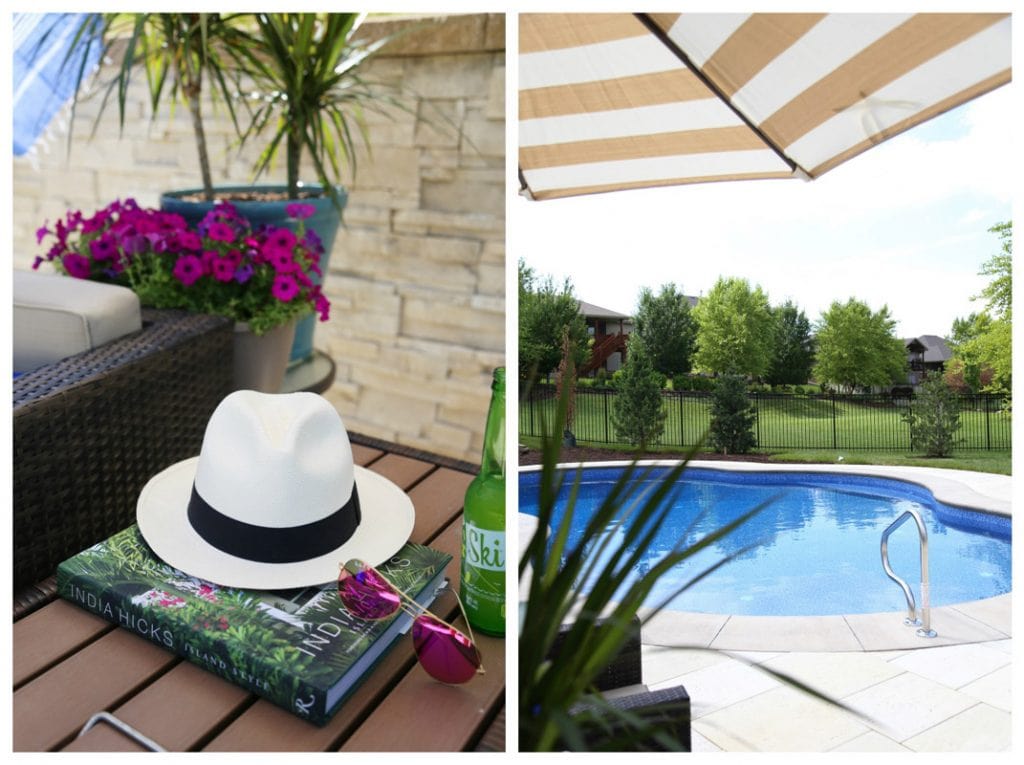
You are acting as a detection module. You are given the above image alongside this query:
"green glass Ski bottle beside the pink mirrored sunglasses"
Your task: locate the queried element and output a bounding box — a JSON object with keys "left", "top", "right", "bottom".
{"left": 460, "top": 367, "right": 505, "bottom": 635}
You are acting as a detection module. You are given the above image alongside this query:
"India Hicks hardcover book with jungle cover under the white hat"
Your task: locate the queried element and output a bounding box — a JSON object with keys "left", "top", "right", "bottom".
{"left": 57, "top": 525, "right": 452, "bottom": 725}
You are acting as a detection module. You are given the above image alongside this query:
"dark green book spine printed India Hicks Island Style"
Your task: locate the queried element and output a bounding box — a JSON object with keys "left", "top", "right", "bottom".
{"left": 57, "top": 564, "right": 329, "bottom": 725}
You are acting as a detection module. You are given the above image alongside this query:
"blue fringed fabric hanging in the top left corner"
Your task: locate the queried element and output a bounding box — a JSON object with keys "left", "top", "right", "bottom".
{"left": 11, "top": 13, "right": 99, "bottom": 157}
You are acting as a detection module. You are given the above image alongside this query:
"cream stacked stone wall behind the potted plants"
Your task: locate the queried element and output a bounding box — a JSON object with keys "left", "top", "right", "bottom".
{"left": 13, "top": 14, "right": 506, "bottom": 462}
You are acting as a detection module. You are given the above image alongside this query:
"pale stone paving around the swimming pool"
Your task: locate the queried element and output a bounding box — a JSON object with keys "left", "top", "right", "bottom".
{"left": 642, "top": 463, "right": 1013, "bottom": 752}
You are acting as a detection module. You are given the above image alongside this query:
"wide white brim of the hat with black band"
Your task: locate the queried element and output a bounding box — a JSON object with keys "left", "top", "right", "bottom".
{"left": 136, "top": 457, "right": 416, "bottom": 590}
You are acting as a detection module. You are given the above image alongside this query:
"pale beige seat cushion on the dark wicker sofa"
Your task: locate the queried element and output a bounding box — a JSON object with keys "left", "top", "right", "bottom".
{"left": 13, "top": 270, "right": 142, "bottom": 372}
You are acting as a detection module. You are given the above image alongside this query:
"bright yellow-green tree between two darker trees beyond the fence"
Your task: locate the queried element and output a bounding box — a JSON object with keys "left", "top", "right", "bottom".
{"left": 693, "top": 278, "right": 772, "bottom": 377}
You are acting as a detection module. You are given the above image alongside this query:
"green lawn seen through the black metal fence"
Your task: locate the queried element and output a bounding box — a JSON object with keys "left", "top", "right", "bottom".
{"left": 519, "top": 390, "right": 1011, "bottom": 472}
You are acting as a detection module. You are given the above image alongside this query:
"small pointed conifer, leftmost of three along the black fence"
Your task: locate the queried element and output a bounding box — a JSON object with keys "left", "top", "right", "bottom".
{"left": 611, "top": 337, "right": 666, "bottom": 453}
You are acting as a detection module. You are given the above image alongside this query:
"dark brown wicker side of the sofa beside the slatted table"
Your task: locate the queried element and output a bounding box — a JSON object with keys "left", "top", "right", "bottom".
{"left": 12, "top": 309, "right": 232, "bottom": 612}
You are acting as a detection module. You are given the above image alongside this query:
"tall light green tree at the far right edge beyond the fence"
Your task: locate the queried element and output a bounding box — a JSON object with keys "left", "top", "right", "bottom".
{"left": 951, "top": 222, "right": 1013, "bottom": 392}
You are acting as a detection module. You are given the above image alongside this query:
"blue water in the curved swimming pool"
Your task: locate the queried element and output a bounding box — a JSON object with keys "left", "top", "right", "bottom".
{"left": 519, "top": 467, "right": 1011, "bottom": 615}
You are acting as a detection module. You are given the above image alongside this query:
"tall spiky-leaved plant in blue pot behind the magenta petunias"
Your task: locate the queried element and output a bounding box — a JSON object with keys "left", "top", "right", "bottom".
{"left": 45, "top": 13, "right": 406, "bottom": 363}
